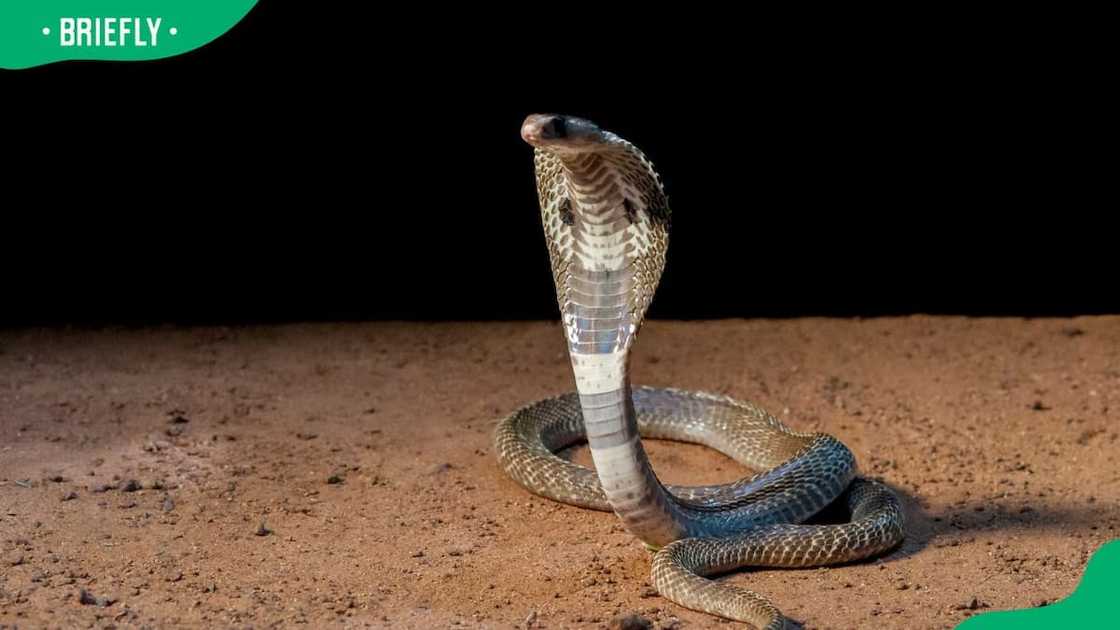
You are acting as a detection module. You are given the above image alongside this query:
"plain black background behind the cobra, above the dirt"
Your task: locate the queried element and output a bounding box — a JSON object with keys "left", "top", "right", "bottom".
{"left": 0, "top": 6, "right": 1120, "bottom": 325}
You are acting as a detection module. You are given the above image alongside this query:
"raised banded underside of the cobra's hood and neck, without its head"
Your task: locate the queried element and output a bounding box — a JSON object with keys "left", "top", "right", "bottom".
{"left": 535, "top": 118, "right": 685, "bottom": 545}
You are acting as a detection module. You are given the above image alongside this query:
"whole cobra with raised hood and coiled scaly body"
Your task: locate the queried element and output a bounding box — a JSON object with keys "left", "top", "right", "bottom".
{"left": 493, "top": 114, "right": 905, "bottom": 630}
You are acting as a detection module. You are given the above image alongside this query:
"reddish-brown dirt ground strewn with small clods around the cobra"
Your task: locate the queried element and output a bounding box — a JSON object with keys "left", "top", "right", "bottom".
{"left": 0, "top": 316, "right": 1120, "bottom": 629}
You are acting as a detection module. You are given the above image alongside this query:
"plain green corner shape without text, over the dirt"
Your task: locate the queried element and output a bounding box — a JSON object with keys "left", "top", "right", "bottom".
{"left": 956, "top": 539, "right": 1120, "bottom": 630}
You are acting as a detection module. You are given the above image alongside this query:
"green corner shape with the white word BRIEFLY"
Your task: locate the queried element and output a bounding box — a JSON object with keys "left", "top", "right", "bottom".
{"left": 0, "top": 0, "right": 256, "bottom": 70}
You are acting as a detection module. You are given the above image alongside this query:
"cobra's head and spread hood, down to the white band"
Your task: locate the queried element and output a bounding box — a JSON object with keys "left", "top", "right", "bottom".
{"left": 521, "top": 114, "right": 670, "bottom": 354}
